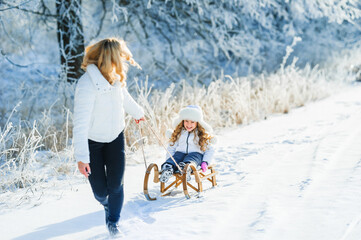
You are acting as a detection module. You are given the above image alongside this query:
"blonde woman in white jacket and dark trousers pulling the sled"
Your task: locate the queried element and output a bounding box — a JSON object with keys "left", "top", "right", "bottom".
{"left": 73, "top": 38, "right": 144, "bottom": 236}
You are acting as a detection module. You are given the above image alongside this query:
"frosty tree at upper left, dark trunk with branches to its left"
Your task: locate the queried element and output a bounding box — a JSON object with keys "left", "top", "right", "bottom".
{"left": 0, "top": 0, "right": 84, "bottom": 82}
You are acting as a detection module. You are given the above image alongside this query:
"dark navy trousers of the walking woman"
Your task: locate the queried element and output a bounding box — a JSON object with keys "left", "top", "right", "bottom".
{"left": 88, "top": 132, "right": 125, "bottom": 223}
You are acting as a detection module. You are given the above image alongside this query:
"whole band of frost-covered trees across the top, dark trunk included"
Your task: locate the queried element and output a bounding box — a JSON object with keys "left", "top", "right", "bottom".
{"left": 0, "top": 0, "right": 361, "bottom": 86}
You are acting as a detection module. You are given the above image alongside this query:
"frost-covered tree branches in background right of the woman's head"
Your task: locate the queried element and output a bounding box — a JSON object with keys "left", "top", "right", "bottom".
{"left": 102, "top": 0, "right": 361, "bottom": 85}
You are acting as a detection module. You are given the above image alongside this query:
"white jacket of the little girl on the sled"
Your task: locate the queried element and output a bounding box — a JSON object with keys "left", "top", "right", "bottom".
{"left": 166, "top": 129, "right": 214, "bottom": 164}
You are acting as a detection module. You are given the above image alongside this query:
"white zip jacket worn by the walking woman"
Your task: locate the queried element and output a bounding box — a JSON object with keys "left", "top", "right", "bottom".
{"left": 73, "top": 64, "right": 144, "bottom": 163}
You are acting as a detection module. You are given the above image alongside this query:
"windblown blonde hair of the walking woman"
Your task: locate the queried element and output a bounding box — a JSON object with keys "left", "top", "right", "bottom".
{"left": 81, "top": 38, "right": 141, "bottom": 85}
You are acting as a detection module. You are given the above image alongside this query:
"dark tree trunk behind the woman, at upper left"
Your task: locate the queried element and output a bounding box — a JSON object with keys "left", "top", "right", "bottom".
{"left": 56, "top": 0, "right": 84, "bottom": 83}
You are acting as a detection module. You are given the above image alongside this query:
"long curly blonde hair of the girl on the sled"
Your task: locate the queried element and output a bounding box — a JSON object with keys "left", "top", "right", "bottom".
{"left": 169, "top": 120, "right": 213, "bottom": 152}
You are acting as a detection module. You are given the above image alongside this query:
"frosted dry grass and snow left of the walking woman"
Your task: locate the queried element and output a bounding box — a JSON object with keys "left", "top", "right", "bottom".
{"left": 0, "top": 105, "right": 76, "bottom": 208}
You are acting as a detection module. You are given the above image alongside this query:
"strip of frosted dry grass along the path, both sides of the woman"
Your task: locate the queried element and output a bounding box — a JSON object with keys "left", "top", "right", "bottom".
{"left": 0, "top": 54, "right": 347, "bottom": 205}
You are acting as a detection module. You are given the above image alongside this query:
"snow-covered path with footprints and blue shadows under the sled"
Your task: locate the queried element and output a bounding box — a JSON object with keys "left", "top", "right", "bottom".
{"left": 0, "top": 85, "right": 361, "bottom": 240}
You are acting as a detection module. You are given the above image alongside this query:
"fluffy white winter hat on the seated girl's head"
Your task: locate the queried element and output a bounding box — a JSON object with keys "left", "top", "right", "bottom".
{"left": 173, "top": 105, "right": 213, "bottom": 133}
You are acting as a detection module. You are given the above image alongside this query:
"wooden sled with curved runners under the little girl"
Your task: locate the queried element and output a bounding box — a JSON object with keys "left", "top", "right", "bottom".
{"left": 144, "top": 163, "right": 218, "bottom": 201}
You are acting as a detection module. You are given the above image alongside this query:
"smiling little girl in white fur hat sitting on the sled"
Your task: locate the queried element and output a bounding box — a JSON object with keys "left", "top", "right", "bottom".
{"left": 159, "top": 105, "right": 214, "bottom": 182}
